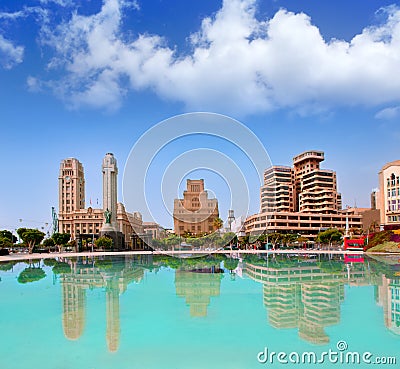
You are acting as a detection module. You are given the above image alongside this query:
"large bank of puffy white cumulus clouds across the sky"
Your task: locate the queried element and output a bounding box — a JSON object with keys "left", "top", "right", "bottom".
{"left": 30, "top": 0, "right": 400, "bottom": 114}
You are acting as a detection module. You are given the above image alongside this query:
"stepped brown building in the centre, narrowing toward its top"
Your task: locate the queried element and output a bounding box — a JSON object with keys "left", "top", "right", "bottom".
{"left": 173, "top": 179, "right": 219, "bottom": 235}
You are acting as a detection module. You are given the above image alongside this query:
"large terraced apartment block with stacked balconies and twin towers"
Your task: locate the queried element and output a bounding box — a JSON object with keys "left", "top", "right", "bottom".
{"left": 245, "top": 150, "right": 363, "bottom": 239}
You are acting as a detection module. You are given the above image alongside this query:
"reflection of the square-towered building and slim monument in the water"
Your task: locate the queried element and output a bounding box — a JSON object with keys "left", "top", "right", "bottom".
{"left": 60, "top": 255, "right": 151, "bottom": 352}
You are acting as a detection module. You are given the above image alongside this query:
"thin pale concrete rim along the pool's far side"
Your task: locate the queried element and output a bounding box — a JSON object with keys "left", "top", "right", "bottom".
{"left": 0, "top": 250, "right": 400, "bottom": 262}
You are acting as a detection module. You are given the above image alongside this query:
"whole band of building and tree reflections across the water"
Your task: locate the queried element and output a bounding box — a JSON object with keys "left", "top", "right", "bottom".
{"left": 0, "top": 255, "right": 400, "bottom": 352}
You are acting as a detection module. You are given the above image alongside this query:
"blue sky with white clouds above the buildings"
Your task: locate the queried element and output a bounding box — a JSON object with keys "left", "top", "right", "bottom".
{"left": 0, "top": 0, "right": 400, "bottom": 229}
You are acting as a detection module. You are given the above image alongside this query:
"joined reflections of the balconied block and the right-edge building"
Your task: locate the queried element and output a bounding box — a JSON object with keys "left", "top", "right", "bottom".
{"left": 243, "top": 255, "right": 400, "bottom": 344}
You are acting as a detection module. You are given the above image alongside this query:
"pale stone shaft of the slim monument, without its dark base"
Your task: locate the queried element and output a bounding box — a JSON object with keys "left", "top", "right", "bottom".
{"left": 101, "top": 153, "right": 118, "bottom": 231}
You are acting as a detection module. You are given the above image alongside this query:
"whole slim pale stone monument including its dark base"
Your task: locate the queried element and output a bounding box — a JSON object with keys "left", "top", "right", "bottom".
{"left": 100, "top": 153, "right": 125, "bottom": 250}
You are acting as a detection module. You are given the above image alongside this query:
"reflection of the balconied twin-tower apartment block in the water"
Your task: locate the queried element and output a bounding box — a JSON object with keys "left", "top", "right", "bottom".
{"left": 244, "top": 258, "right": 366, "bottom": 344}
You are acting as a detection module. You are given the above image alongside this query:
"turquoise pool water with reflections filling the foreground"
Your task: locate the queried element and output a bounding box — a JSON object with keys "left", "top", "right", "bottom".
{"left": 0, "top": 255, "right": 400, "bottom": 369}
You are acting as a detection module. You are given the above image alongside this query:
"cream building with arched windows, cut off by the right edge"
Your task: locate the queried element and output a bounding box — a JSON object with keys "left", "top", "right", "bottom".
{"left": 377, "top": 160, "right": 400, "bottom": 228}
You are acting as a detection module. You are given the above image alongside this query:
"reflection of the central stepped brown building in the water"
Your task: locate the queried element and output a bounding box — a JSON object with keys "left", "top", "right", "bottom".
{"left": 175, "top": 265, "right": 223, "bottom": 317}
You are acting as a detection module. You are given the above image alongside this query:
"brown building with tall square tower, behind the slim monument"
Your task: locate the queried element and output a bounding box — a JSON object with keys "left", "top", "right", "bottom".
{"left": 58, "top": 154, "right": 143, "bottom": 247}
